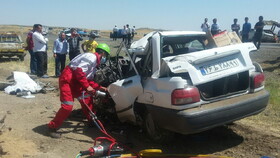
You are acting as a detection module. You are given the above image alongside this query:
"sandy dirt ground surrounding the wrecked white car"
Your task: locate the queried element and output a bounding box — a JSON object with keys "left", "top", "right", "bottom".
{"left": 0, "top": 39, "right": 280, "bottom": 158}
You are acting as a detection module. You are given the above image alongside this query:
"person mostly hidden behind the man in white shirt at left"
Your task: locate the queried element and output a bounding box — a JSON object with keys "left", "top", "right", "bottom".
{"left": 26, "top": 25, "right": 37, "bottom": 75}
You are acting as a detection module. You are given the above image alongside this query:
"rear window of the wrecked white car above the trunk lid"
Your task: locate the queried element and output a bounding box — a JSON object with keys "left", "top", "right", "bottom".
{"left": 161, "top": 35, "right": 206, "bottom": 58}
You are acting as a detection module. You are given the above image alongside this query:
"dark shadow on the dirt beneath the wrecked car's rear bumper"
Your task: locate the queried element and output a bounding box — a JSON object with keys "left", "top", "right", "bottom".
{"left": 121, "top": 126, "right": 244, "bottom": 155}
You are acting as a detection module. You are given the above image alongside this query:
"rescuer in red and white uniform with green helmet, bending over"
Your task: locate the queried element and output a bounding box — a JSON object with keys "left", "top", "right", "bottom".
{"left": 48, "top": 43, "right": 110, "bottom": 138}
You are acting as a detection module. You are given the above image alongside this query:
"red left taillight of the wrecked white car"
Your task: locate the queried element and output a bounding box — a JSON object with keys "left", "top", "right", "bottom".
{"left": 171, "top": 87, "right": 200, "bottom": 105}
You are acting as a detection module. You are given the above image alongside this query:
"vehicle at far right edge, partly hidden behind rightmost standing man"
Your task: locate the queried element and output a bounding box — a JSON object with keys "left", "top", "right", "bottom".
{"left": 249, "top": 20, "right": 280, "bottom": 43}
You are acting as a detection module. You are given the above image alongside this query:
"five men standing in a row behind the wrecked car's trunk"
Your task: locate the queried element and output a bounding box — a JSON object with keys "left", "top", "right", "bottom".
{"left": 201, "top": 16, "right": 265, "bottom": 49}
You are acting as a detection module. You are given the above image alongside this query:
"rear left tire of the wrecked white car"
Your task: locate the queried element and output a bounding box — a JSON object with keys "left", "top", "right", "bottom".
{"left": 144, "top": 112, "right": 174, "bottom": 143}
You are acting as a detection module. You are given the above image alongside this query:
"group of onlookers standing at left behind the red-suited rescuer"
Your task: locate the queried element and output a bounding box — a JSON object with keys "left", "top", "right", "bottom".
{"left": 26, "top": 27, "right": 98, "bottom": 78}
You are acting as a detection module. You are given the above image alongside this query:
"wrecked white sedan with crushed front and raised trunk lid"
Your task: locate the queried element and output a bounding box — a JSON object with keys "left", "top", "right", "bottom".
{"left": 95, "top": 31, "right": 269, "bottom": 141}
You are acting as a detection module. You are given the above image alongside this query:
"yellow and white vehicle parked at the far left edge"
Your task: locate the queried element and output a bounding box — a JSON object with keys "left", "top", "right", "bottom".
{"left": 0, "top": 32, "right": 26, "bottom": 61}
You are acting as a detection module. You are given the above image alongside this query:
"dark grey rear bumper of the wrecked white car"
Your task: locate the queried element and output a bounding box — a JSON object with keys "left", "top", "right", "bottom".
{"left": 147, "top": 90, "right": 269, "bottom": 134}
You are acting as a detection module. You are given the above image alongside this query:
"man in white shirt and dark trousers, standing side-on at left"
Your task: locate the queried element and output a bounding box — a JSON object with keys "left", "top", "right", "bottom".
{"left": 32, "top": 24, "right": 49, "bottom": 78}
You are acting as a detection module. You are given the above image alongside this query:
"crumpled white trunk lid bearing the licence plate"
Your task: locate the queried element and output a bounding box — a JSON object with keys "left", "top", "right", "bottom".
{"left": 162, "top": 44, "right": 255, "bottom": 85}
